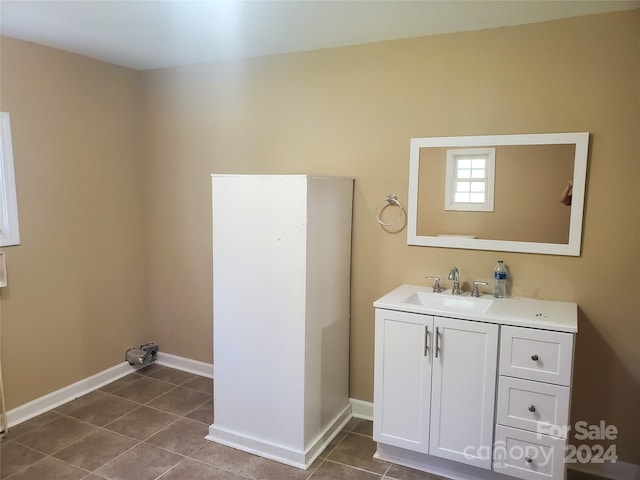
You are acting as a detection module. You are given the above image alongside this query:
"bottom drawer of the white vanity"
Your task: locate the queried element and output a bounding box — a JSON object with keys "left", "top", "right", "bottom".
{"left": 493, "top": 425, "right": 566, "bottom": 480}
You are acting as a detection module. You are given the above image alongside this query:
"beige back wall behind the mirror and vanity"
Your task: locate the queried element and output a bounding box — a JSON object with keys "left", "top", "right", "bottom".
{"left": 144, "top": 12, "right": 640, "bottom": 462}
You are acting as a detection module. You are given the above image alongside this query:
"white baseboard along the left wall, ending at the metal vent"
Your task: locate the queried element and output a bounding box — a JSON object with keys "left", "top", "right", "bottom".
{"left": 7, "top": 362, "right": 135, "bottom": 428}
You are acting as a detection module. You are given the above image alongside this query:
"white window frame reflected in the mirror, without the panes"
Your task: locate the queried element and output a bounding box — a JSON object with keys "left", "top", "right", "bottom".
{"left": 444, "top": 148, "right": 496, "bottom": 212}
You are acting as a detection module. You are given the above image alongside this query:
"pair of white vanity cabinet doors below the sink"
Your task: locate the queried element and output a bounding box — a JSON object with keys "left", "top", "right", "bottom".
{"left": 374, "top": 309, "right": 498, "bottom": 469}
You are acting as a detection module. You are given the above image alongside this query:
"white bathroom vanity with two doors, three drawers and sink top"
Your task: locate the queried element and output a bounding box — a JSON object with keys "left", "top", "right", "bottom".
{"left": 373, "top": 285, "right": 578, "bottom": 480}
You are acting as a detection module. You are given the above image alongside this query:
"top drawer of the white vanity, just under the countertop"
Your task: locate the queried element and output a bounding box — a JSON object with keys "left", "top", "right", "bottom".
{"left": 500, "top": 327, "right": 574, "bottom": 386}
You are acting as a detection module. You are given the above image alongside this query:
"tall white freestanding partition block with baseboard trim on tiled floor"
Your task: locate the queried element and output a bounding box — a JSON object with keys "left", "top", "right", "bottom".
{"left": 207, "top": 175, "right": 353, "bottom": 468}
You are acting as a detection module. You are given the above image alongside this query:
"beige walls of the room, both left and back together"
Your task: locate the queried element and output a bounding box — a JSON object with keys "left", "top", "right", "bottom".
{"left": 2, "top": 11, "right": 640, "bottom": 463}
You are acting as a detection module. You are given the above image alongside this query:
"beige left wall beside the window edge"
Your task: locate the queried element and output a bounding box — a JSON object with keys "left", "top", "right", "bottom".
{"left": 0, "top": 37, "right": 149, "bottom": 409}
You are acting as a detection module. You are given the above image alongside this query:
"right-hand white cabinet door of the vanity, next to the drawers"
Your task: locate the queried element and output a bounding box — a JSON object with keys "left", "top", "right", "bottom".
{"left": 429, "top": 317, "right": 498, "bottom": 469}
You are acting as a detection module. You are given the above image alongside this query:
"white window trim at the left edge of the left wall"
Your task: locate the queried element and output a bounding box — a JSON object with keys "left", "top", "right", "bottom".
{"left": 0, "top": 112, "right": 20, "bottom": 247}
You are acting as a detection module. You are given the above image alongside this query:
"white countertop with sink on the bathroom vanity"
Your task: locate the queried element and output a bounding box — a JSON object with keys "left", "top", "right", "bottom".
{"left": 373, "top": 285, "right": 578, "bottom": 333}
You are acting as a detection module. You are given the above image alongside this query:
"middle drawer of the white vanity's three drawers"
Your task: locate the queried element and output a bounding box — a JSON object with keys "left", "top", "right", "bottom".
{"left": 497, "top": 376, "right": 569, "bottom": 437}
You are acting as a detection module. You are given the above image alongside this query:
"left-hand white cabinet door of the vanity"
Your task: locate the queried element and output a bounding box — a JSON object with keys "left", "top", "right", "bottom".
{"left": 373, "top": 309, "right": 433, "bottom": 453}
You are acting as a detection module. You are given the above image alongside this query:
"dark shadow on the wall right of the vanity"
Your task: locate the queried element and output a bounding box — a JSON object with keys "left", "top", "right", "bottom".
{"left": 568, "top": 309, "right": 640, "bottom": 465}
